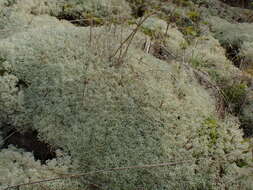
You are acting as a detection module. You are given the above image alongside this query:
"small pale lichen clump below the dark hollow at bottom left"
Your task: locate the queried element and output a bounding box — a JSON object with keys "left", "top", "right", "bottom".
{"left": 0, "top": 146, "right": 80, "bottom": 190}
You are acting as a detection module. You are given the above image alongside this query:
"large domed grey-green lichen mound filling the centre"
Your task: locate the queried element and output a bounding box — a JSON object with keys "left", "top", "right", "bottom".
{"left": 0, "top": 21, "right": 251, "bottom": 189}
